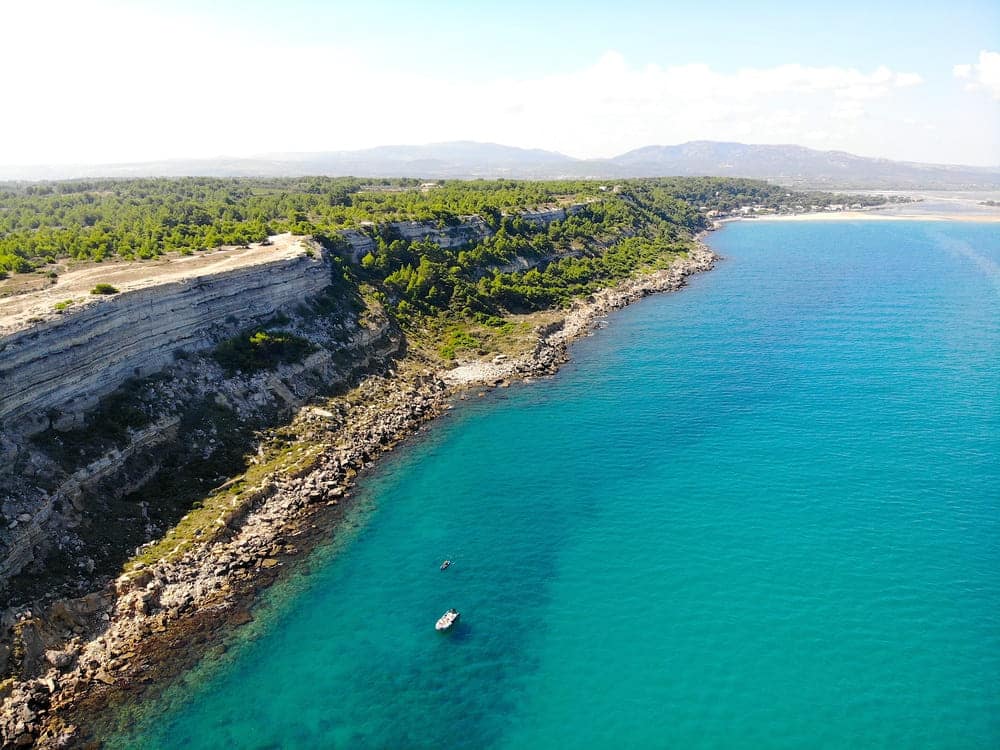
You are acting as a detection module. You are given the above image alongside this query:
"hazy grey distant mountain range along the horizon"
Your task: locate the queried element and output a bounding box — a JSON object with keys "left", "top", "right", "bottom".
{"left": 0, "top": 141, "right": 1000, "bottom": 190}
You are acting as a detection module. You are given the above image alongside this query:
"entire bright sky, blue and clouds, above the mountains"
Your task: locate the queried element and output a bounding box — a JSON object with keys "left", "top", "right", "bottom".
{"left": 0, "top": 0, "right": 1000, "bottom": 165}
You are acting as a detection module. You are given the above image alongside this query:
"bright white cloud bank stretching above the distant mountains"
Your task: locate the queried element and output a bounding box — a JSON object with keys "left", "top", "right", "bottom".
{"left": 0, "top": 0, "right": 948, "bottom": 163}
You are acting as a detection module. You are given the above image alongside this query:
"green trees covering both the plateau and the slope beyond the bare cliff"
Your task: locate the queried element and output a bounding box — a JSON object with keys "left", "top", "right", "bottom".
{"left": 0, "top": 177, "right": 880, "bottom": 362}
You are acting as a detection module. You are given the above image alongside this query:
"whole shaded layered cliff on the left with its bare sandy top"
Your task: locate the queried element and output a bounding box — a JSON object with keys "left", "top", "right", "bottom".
{"left": 0, "top": 205, "right": 592, "bottom": 604}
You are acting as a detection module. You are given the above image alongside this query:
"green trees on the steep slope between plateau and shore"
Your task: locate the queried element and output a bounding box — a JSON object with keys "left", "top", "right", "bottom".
{"left": 359, "top": 185, "right": 705, "bottom": 325}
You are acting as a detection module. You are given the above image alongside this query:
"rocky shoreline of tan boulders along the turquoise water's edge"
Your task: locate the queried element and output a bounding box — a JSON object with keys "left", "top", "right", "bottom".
{"left": 0, "top": 242, "right": 716, "bottom": 748}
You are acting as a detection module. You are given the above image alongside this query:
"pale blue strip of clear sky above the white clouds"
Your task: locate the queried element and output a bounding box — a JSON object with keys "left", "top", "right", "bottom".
{"left": 182, "top": 0, "right": 1000, "bottom": 78}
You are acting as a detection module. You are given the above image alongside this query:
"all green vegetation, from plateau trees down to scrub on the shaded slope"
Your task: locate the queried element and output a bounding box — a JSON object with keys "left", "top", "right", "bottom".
{"left": 0, "top": 178, "right": 884, "bottom": 612}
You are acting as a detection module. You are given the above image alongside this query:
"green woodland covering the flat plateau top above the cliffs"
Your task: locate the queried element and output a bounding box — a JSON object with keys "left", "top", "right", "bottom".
{"left": 0, "top": 177, "right": 872, "bottom": 276}
